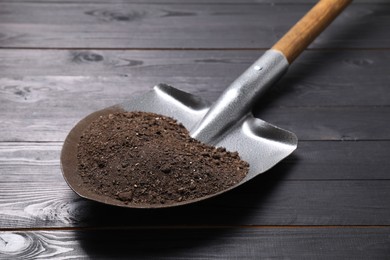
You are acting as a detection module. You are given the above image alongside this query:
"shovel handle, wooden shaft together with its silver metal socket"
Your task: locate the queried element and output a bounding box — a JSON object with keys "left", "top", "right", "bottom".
{"left": 190, "top": 0, "right": 352, "bottom": 143}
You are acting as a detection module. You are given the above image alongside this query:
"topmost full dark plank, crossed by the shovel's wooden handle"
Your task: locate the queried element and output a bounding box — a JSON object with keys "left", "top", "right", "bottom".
{"left": 0, "top": 2, "right": 390, "bottom": 49}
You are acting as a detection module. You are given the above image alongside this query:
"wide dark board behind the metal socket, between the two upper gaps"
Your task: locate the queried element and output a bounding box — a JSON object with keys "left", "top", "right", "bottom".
{"left": 0, "top": 50, "right": 390, "bottom": 141}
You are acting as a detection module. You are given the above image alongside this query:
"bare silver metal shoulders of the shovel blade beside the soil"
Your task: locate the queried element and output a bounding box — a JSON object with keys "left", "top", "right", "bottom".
{"left": 118, "top": 84, "right": 297, "bottom": 182}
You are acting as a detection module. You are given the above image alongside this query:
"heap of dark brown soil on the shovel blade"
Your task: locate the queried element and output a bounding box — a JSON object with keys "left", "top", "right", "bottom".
{"left": 77, "top": 112, "right": 249, "bottom": 205}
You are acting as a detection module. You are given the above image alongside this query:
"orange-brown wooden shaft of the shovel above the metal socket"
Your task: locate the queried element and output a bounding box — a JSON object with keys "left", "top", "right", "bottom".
{"left": 272, "top": 0, "right": 352, "bottom": 64}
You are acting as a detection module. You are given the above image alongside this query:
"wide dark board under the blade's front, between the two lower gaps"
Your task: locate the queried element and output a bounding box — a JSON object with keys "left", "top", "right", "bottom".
{"left": 0, "top": 142, "right": 390, "bottom": 228}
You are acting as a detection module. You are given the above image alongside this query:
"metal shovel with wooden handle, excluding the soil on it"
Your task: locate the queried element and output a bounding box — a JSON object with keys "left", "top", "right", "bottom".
{"left": 61, "top": 0, "right": 352, "bottom": 208}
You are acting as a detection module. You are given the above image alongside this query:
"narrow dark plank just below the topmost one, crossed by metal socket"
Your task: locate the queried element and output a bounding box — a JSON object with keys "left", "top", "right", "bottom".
{"left": 0, "top": 50, "right": 390, "bottom": 107}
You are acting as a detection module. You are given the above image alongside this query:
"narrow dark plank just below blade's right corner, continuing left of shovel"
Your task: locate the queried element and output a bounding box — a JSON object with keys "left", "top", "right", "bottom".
{"left": 0, "top": 141, "right": 390, "bottom": 183}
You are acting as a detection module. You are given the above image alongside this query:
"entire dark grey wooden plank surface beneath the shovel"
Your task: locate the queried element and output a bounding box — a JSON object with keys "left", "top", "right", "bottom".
{"left": 0, "top": 0, "right": 390, "bottom": 259}
